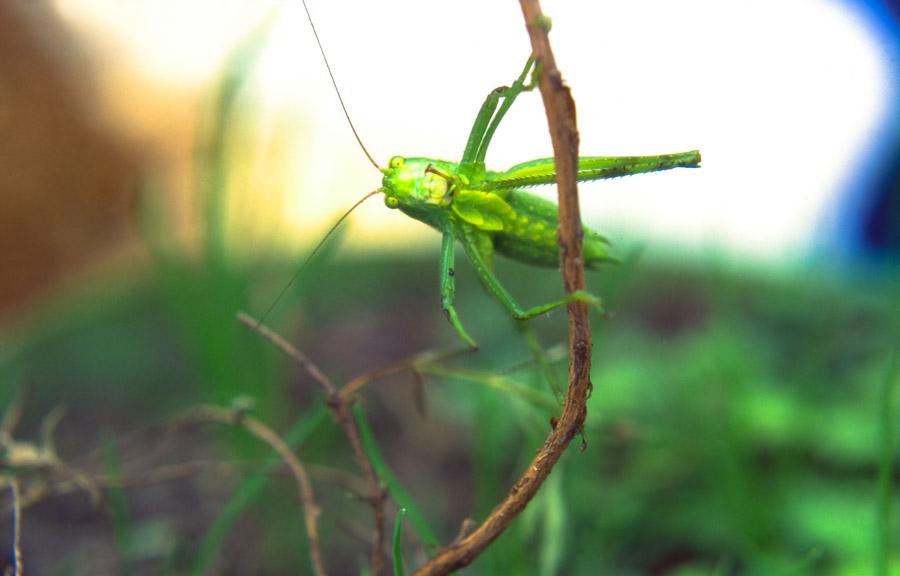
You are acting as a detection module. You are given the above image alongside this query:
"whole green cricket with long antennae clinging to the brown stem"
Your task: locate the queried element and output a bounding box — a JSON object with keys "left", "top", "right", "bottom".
{"left": 270, "top": 0, "right": 700, "bottom": 348}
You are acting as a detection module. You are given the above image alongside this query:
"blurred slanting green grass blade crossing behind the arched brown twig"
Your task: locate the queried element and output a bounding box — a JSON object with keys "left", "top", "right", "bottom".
{"left": 190, "top": 404, "right": 329, "bottom": 576}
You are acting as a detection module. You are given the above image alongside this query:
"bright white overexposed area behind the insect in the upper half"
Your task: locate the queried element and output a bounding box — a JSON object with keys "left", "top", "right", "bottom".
{"left": 57, "top": 0, "right": 895, "bottom": 260}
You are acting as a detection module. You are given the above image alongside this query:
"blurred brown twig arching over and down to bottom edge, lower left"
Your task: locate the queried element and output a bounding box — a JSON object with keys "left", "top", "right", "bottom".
{"left": 189, "top": 406, "right": 325, "bottom": 576}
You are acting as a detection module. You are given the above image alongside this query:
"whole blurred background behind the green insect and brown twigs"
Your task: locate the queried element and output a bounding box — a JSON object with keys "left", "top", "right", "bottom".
{"left": 0, "top": 0, "right": 900, "bottom": 574}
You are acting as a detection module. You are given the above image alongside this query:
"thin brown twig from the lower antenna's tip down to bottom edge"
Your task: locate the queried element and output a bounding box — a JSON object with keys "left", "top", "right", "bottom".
{"left": 237, "top": 312, "right": 386, "bottom": 576}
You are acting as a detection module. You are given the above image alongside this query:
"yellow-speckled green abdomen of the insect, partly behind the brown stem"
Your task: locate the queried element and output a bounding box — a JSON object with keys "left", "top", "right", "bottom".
{"left": 494, "top": 190, "right": 616, "bottom": 268}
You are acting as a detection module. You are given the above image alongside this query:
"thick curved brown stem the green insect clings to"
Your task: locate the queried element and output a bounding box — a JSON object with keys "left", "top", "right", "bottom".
{"left": 415, "top": 0, "right": 591, "bottom": 575}
